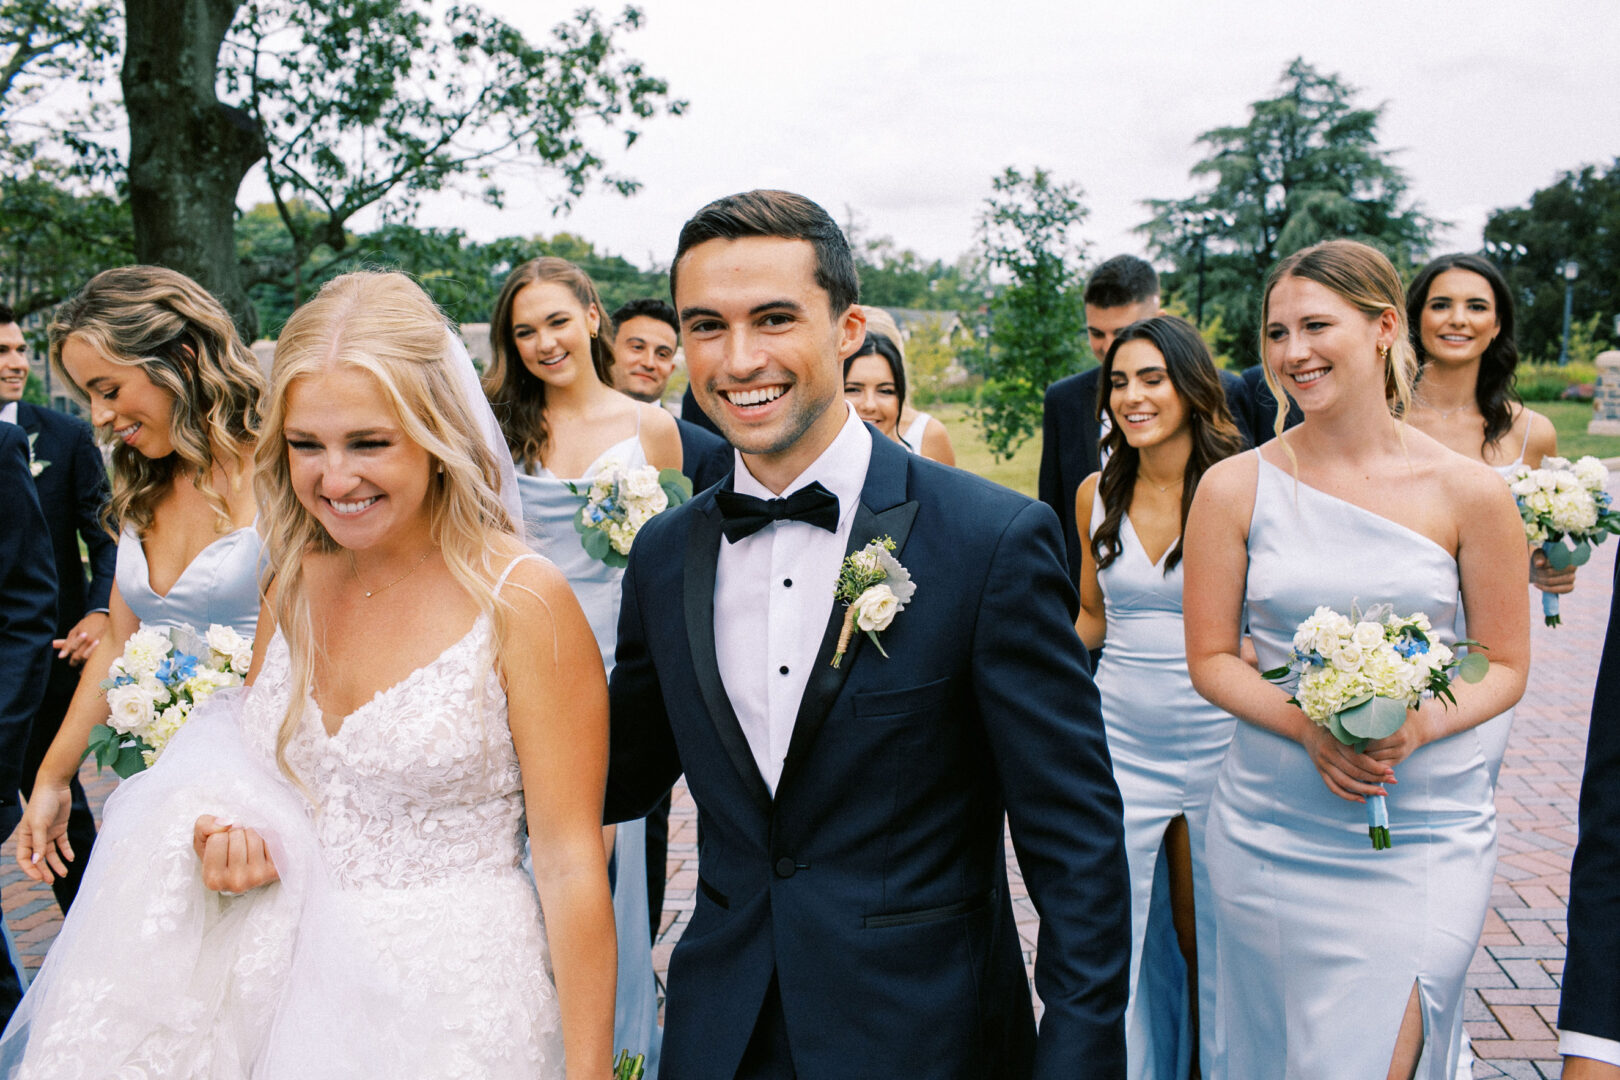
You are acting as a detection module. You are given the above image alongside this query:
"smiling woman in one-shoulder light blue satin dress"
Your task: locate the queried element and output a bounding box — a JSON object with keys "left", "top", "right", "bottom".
{"left": 1184, "top": 240, "right": 1529, "bottom": 1080}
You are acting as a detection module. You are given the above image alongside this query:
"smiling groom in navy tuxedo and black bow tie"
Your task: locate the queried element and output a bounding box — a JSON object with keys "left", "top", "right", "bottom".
{"left": 608, "top": 191, "right": 1129, "bottom": 1080}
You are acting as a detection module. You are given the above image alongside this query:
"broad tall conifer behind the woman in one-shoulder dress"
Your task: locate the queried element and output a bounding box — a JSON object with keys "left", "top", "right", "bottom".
{"left": 1140, "top": 58, "right": 1437, "bottom": 363}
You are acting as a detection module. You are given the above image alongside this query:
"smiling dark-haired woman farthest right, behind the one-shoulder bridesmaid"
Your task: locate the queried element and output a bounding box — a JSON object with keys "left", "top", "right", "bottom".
{"left": 1406, "top": 254, "right": 1575, "bottom": 593}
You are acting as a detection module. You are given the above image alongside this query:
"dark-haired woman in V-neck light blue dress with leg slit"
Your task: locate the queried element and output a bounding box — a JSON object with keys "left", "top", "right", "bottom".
{"left": 1074, "top": 316, "right": 1246, "bottom": 1080}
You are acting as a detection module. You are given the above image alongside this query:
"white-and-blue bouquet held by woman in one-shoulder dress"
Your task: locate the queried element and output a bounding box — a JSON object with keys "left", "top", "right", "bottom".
{"left": 1264, "top": 604, "right": 1490, "bottom": 850}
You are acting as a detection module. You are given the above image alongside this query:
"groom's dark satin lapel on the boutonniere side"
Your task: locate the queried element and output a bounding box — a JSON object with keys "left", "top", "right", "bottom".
{"left": 776, "top": 426, "right": 917, "bottom": 795}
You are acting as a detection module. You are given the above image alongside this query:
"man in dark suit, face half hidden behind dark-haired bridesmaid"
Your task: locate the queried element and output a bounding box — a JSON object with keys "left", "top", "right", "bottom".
{"left": 1037, "top": 254, "right": 1252, "bottom": 581}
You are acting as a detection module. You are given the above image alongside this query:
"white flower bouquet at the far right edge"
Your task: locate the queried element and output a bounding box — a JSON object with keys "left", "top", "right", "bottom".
{"left": 1508, "top": 455, "right": 1620, "bottom": 627}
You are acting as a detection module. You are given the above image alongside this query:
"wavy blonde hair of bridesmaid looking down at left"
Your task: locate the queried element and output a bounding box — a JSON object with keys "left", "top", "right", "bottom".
{"left": 49, "top": 266, "right": 264, "bottom": 536}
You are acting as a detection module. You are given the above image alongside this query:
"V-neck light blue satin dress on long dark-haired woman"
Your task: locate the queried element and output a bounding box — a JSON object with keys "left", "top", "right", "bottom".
{"left": 1092, "top": 494, "right": 1238, "bottom": 1080}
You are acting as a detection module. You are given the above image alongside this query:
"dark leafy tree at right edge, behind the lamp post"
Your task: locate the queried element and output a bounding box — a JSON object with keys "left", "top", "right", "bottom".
{"left": 1486, "top": 159, "right": 1620, "bottom": 361}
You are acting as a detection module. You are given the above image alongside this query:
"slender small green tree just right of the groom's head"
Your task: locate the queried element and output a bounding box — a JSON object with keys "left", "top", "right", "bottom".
{"left": 962, "top": 168, "right": 1087, "bottom": 458}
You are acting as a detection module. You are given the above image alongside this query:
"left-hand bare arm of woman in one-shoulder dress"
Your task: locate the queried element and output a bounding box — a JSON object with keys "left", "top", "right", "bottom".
{"left": 1181, "top": 453, "right": 1395, "bottom": 801}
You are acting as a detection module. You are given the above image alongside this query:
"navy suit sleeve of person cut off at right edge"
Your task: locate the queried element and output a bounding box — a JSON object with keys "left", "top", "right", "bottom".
{"left": 1558, "top": 560, "right": 1620, "bottom": 1041}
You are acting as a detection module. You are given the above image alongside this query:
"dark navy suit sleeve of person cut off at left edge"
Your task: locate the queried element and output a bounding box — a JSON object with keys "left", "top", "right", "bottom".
{"left": 0, "top": 423, "right": 57, "bottom": 836}
